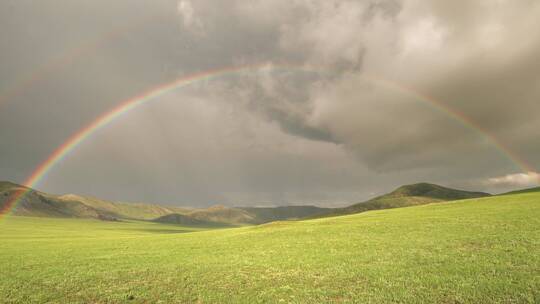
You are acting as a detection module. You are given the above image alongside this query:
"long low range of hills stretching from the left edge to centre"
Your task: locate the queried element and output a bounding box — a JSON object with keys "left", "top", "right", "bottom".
{"left": 0, "top": 182, "right": 330, "bottom": 226}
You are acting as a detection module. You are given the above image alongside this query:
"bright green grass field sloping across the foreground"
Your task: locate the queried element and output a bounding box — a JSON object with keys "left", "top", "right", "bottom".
{"left": 0, "top": 193, "right": 540, "bottom": 303}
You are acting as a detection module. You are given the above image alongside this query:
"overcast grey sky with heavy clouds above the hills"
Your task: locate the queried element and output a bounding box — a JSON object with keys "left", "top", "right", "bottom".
{"left": 0, "top": 0, "right": 540, "bottom": 207}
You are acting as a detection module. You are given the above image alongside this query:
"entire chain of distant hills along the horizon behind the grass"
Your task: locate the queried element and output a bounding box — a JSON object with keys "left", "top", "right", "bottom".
{"left": 0, "top": 182, "right": 492, "bottom": 225}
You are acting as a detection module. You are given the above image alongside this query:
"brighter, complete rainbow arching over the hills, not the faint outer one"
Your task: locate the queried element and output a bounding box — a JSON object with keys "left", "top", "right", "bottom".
{"left": 0, "top": 63, "right": 534, "bottom": 216}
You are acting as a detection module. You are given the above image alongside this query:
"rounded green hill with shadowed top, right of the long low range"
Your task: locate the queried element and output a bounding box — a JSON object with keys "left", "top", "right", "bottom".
{"left": 316, "top": 183, "right": 491, "bottom": 216}
